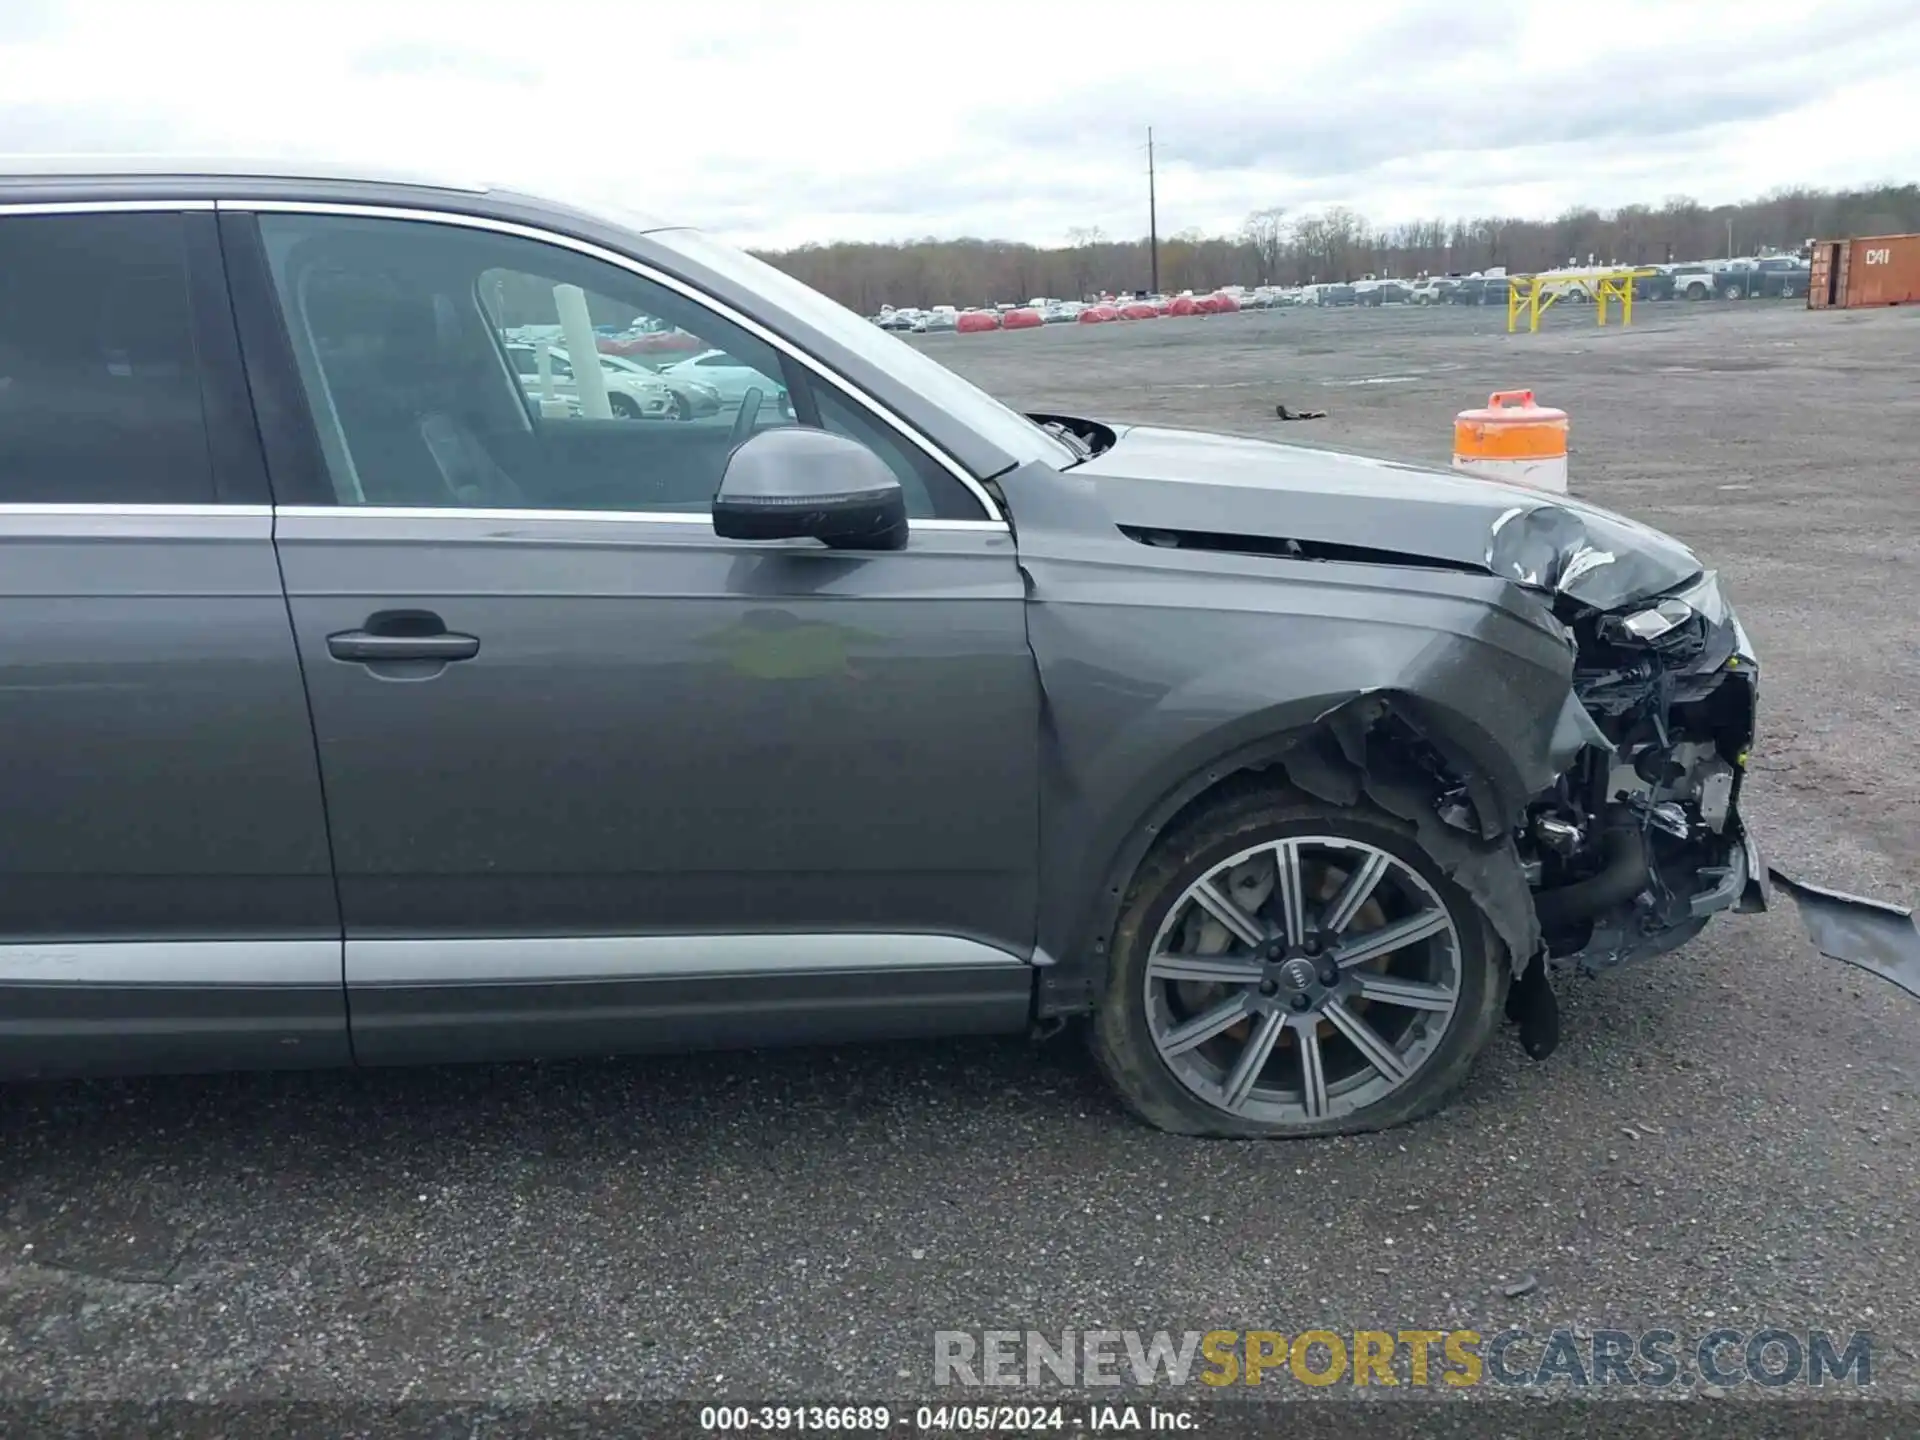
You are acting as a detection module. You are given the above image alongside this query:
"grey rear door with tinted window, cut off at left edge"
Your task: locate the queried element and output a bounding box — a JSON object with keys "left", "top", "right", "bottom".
{"left": 0, "top": 205, "right": 348, "bottom": 1073}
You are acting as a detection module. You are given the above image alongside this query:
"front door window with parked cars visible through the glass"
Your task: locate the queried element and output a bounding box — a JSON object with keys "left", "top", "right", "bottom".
{"left": 259, "top": 215, "right": 981, "bottom": 518}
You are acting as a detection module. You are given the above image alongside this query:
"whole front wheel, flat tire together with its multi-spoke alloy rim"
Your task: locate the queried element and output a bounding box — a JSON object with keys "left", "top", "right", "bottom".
{"left": 1091, "top": 791, "right": 1511, "bottom": 1139}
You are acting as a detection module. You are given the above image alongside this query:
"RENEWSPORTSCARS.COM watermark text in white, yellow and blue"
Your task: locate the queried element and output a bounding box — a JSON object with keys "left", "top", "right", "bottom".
{"left": 933, "top": 1327, "right": 1874, "bottom": 1390}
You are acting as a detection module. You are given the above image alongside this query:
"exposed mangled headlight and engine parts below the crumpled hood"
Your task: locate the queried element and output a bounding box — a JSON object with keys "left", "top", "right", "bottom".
{"left": 1517, "top": 572, "right": 1761, "bottom": 972}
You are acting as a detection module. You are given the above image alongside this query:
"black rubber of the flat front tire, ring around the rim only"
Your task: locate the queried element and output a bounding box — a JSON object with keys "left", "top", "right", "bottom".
{"left": 1094, "top": 804, "right": 1507, "bottom": 1137}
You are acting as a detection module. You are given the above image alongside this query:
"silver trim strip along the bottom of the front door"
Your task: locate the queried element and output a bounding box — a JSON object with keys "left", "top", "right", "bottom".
{"left": 346, "top": 933, "right": 1031, "bottom": 989}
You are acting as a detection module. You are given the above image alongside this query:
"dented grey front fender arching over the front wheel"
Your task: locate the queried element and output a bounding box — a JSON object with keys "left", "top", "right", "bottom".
{"left": 1021, "top": 532, "right": 1586, "bottom": 1010}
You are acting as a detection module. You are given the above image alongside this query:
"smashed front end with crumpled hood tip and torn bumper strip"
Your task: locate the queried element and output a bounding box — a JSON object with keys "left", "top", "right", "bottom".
{"left": 1488, "top": 505, "right": 1920, "bottom": 1010}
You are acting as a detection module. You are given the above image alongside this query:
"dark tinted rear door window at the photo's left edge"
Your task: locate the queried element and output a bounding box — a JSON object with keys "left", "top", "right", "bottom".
{"left": 0, "top": 215, "right": 215, "bottom": 505}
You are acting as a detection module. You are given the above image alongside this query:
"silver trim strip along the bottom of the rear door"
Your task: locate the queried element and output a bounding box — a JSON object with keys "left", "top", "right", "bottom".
{"left": 0, "top": 939, "right": 346, "bottom": 989}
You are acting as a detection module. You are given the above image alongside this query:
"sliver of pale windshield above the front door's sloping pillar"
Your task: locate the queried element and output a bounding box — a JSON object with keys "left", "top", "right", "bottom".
{"left": 647, "top": 230, "right": 1081, "bottom": 467}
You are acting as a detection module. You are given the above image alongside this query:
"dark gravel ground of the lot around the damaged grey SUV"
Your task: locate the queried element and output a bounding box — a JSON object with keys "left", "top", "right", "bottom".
{"left": 0, "top": 303, "right": 1920, "bottom": 1402}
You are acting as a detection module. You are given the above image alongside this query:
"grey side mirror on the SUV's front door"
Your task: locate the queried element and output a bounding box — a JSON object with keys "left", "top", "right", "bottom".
{"left": 714, "top": 426, "right": 906, "bottom": 549}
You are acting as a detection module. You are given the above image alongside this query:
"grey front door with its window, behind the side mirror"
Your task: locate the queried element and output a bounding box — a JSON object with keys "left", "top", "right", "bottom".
{"left": 236, "top": 213, "right": 1039, "bottom": 1062}
